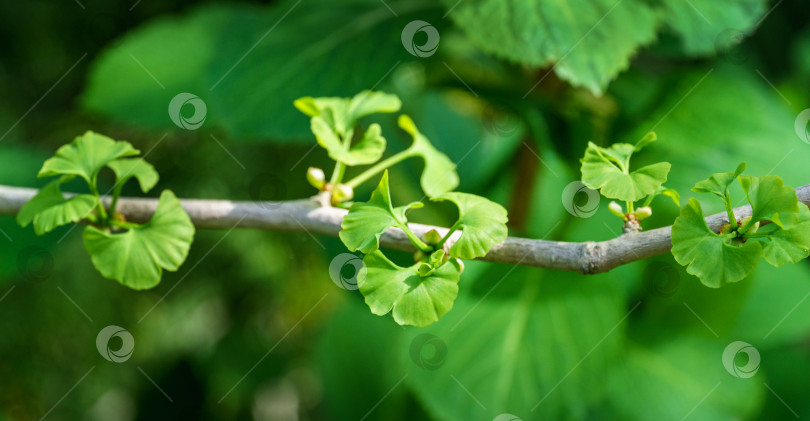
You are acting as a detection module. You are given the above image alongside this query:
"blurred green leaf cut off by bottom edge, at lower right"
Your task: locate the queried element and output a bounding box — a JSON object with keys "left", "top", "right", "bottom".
{"left": 608, "top": 337, "right": 764, "bottom": 421}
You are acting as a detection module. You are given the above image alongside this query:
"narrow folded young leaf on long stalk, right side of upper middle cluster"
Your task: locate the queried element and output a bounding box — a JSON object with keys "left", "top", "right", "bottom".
{"left": 399, "top": 114, "right": 459, "bottom": 197}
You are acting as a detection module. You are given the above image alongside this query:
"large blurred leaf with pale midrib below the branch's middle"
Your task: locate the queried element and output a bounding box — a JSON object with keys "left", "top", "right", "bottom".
{"left": 408, "top": 268, "right": 627, "bottom": 421}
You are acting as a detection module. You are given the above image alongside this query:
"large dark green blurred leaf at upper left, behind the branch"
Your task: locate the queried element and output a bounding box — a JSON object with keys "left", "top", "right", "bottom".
{"left": 83, "top": 0, "right": 431, "bottom": 139}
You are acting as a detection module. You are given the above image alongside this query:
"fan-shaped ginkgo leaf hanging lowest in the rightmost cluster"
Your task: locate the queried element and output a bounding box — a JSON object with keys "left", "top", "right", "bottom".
{"left": 672, "top": 198, "right": 762, "bottom": 288}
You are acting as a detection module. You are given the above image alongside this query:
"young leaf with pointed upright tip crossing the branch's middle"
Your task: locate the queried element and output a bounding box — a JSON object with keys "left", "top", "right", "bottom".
{"left": 339, "top": 171, "right": 423, "bottom": 254}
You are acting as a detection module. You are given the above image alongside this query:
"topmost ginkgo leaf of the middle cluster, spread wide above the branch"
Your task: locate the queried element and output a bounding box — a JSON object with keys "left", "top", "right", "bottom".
{"left": 293, "top": 91, "right": 402, "bottom": 136}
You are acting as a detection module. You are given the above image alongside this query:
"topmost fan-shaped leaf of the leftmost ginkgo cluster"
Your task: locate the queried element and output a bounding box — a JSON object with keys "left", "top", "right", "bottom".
{"left": 39, "top": 131, "right": 140, "bottom": 186}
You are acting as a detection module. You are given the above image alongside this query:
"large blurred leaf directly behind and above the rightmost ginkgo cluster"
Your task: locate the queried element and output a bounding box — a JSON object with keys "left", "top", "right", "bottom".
{"left": 620, "top": 65, "right": 810, "bottom": 199}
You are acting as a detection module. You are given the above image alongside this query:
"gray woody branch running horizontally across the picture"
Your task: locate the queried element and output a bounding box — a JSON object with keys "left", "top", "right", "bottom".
{"left": 0, "top": 184, "right": 810, "bottom": 274}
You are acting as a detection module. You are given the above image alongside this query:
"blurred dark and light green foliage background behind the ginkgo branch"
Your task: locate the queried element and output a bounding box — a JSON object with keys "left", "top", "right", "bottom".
{"left": 0, "top": 0, "right": 810, "bottom": 420}
